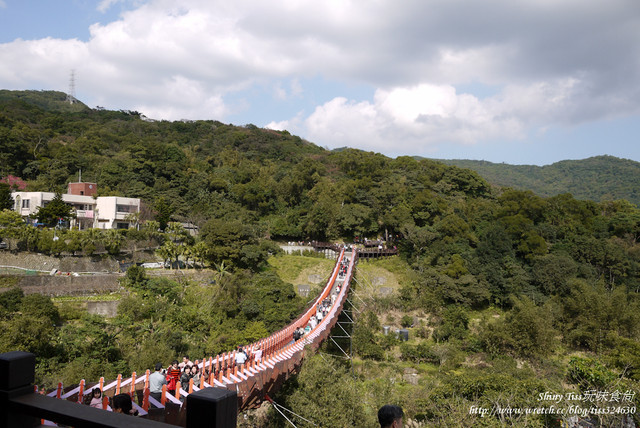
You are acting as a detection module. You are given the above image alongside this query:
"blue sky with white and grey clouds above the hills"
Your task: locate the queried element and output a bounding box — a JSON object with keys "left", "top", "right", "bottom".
{"left": 0, "top": 0, "right": 640, "bottom": 165}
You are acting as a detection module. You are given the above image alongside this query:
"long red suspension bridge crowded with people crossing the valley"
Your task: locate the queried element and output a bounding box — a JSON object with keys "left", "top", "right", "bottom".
{"left": 36, "top": 248, "right": 358, "bottom": 426}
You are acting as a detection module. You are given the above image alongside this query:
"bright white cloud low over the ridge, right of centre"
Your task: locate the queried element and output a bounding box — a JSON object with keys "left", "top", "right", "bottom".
{"left": 296, "top": 79, "right": 604, "bottom": 154}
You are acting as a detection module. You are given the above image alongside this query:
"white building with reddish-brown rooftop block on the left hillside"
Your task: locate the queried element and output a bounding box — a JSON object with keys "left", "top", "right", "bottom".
{"left": 11, "top": 183, "right": 140, "bottom": 229}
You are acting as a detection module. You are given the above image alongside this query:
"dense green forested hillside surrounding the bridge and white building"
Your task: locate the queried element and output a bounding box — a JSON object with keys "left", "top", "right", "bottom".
{"left": 0, "top": 90, "right": 640, "bottom": 427}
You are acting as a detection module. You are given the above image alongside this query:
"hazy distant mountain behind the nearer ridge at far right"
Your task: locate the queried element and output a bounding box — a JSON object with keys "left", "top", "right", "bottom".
{"left": 434, "top": 156, "right": 640, "bottom": 206}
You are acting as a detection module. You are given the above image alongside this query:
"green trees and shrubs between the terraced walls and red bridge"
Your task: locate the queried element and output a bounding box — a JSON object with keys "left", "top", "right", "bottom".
{"left": 0, "top": 268, "right": 303, "bottom": 387}
